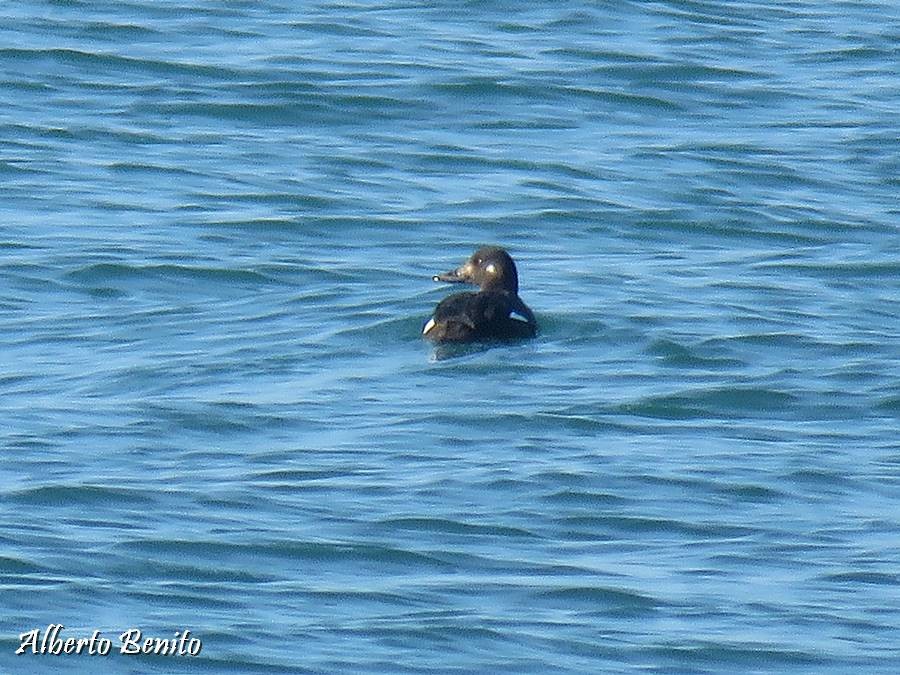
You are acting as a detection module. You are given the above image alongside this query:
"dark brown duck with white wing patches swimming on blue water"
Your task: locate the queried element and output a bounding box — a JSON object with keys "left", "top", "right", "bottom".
{"left": 422, "top": 246, "right": 538, "bottom": 342}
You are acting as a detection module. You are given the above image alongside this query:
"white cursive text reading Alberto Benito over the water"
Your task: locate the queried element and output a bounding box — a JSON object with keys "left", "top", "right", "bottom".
{"left": 16, "top": 623, "right": 203, "bottom": 656}
